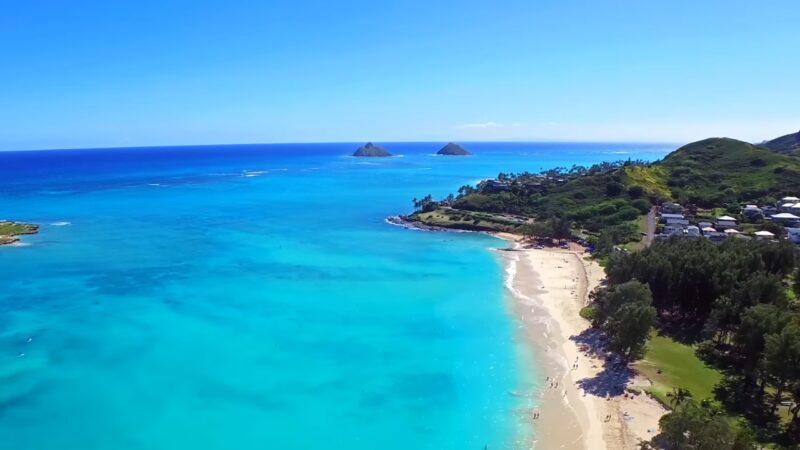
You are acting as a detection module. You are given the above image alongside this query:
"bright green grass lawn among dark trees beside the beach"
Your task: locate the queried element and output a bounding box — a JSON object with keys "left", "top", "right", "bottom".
{"left": 635, "top": 334, "right": 722, "bottom": 405}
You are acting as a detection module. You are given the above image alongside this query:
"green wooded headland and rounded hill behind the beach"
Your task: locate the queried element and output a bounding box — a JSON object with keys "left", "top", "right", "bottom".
{"left": 411, "top": 138, "right": 800, "bottom": 243}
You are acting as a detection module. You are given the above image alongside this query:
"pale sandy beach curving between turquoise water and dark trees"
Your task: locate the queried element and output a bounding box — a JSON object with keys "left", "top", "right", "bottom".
{"left": 499, "top": 235, "right": 666, "bottom": 450}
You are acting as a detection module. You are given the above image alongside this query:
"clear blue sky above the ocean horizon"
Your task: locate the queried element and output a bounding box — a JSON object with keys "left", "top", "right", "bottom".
{"left": 0, "top": 0, "right": 800, "bottom": 150}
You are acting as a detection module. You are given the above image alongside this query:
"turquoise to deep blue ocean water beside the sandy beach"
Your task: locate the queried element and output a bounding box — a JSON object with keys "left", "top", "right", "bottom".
{"left": 0, "top": 143, "right": 674, "bottom": 450}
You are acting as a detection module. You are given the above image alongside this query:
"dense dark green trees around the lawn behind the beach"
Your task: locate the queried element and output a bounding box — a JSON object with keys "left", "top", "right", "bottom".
{"left": 593, "top": 238, "right": 800, "bottom": 449}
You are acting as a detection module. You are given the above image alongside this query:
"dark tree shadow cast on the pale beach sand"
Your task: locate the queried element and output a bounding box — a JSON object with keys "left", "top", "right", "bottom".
{"left": 570, "top": 328, "right": 635, "bottom": 397}
